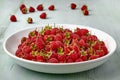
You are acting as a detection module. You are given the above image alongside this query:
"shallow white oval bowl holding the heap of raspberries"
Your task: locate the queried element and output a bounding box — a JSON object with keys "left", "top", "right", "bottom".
{"left": 3, "top": 24, "right": 116, "bottom": 74}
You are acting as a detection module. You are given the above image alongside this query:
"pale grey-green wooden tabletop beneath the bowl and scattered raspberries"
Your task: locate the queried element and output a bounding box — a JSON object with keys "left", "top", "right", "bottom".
{"left": 0, "top": 0, "right": 120, "bottom": 80}
